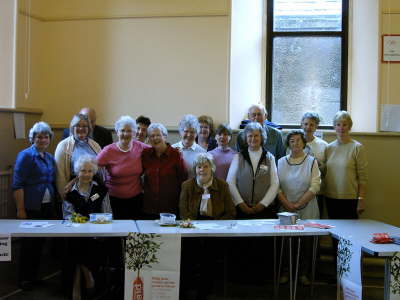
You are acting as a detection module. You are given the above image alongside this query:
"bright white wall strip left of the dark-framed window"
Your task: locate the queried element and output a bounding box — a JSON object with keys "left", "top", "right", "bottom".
{"left": 229, "top": 0, "right": 265, "bottom": 128}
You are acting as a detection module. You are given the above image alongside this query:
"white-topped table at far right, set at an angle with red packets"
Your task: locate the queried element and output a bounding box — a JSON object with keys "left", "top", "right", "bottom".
{"left": 315, "top": 220, "right": 400, "bottom": 300}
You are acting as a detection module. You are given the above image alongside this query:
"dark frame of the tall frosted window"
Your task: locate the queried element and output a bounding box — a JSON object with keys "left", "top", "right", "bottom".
{"left": 265, "top": 0, "right": 349, "bottom": 129}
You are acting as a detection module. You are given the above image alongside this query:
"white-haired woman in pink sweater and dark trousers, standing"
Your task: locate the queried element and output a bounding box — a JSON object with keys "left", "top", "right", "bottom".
{"left": 97, "top": 116, "right": 149, "bottom": 219}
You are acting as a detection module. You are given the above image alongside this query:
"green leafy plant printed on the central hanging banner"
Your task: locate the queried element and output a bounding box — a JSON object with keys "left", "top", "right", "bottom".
{"left": 125, "top": 232, "right": 162, "bottom": 271}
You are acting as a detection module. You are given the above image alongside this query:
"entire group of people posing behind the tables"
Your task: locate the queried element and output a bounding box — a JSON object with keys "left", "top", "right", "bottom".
{"left": 13, "top": 105, "right": 367, "bottom": 298}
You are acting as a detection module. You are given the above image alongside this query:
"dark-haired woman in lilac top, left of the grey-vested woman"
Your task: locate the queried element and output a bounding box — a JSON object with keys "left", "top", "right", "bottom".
{"left": 209, "top": 124, "right": 236, "bottom": 180}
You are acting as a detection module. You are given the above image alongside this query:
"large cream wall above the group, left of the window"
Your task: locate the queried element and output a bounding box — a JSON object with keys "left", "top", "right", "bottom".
{"left": 16, "top": 1, "right": 229, "bottom": 126}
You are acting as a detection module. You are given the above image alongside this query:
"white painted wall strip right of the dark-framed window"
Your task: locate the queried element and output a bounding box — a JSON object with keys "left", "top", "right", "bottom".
{"left": 348, "top": 0, "right": 380, "bottom": 132}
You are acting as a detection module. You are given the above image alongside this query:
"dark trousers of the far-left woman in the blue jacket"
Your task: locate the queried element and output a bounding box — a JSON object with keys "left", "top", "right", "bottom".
{"left": 18, "top": 203, "right": 53, "bottom": 282}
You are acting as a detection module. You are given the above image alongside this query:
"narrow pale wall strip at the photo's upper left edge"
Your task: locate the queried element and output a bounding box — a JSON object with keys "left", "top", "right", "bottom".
{"left": 0, "top": 0, "right": 17, "bottom": 108}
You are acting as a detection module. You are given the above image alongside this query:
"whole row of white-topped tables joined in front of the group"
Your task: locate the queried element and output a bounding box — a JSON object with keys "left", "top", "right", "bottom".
{"left": 0, "top": 220, "right": 400, "bottom": 299}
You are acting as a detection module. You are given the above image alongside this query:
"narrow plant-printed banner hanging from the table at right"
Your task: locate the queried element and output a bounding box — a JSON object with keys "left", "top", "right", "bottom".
{"left": 337, "top": 238, "right": 362, "bottom": 300}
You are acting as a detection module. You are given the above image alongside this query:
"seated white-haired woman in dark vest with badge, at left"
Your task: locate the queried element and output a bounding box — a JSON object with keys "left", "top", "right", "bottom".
{"left": 63, "top": 155, "right": 111, "bottom": 299}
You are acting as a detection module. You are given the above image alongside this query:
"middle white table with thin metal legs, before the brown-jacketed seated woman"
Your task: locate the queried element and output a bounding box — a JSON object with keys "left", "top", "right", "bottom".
{"left": 136, "top": 219, "right": 330, "bottom": 299}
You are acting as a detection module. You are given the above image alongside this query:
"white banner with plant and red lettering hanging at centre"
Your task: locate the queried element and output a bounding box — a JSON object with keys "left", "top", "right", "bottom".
{"left": 125, "top": 233, "right": 181, "bottom": 300}
